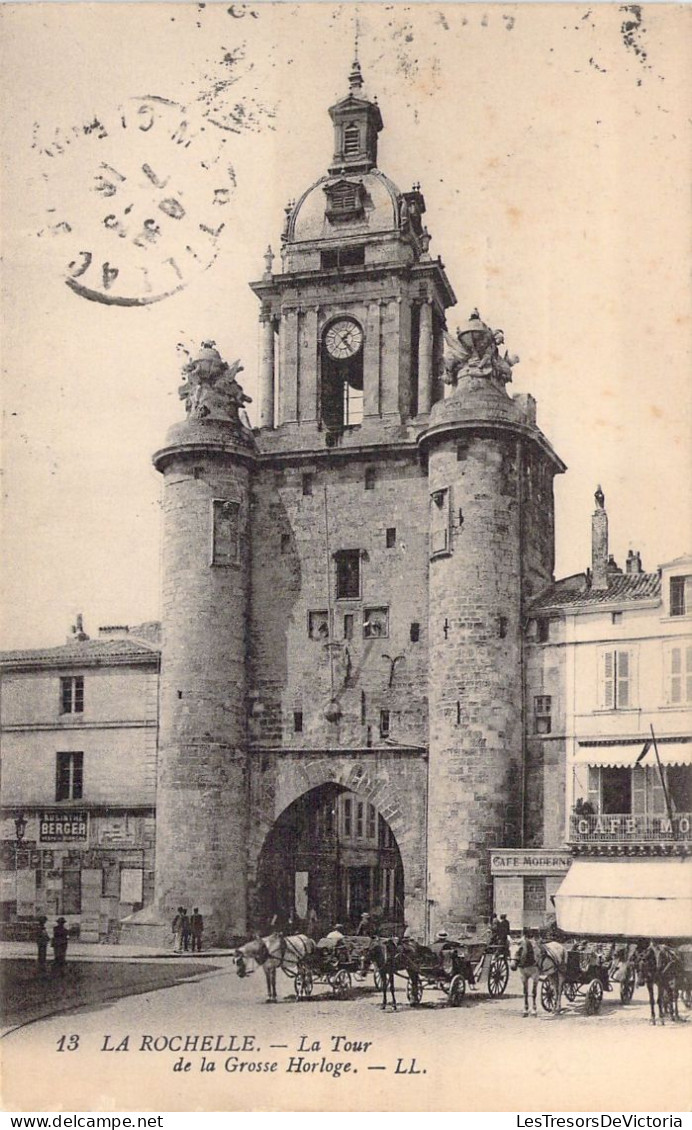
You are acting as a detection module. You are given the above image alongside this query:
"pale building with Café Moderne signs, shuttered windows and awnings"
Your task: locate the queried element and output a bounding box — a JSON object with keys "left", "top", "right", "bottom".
{"left": 513, "top": 488, "right": 692, "bottom": 935}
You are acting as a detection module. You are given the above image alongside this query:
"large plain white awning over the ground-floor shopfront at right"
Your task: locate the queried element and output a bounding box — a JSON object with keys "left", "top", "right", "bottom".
{"left": 555, "top": 858, "right": 692, "bottom": 938}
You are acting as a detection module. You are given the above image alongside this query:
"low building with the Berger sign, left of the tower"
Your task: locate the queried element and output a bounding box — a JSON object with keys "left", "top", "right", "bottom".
{"left": 0, "top": 617, "right": 159, "bottom": 941}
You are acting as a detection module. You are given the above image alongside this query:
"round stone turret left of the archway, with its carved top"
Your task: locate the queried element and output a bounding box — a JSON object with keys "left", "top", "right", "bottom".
{"left": 154, "top": 344, "right": 254, "bottom": 942}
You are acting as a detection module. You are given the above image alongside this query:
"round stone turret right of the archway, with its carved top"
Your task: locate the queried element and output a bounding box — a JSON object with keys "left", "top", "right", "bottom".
{"left": 418, "top": 336, "right": 564, "bottom": 936}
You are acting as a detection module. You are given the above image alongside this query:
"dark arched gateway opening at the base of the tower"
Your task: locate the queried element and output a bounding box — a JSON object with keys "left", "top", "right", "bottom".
{"left": 253, "top": 783, "right": 404, "bottom": 936}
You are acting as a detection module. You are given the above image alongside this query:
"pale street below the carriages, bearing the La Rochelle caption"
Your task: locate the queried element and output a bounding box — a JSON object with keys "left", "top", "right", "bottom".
{"left": 1, "top": 957, "right": 692, "bottom": 1112}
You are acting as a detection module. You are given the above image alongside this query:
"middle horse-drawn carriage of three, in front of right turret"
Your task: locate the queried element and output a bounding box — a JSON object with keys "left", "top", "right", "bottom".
{"left": 406, "top": 941, "right": 509, "bottom": 1007}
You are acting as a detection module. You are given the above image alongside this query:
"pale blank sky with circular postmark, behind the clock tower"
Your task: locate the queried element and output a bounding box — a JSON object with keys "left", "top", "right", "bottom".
{"left": 0, "top": 2, "right": 692, "bottom": 649}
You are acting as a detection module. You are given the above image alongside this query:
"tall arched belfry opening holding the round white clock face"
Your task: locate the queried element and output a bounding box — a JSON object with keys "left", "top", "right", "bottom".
{"left": 320, "top": 318, "right": 363, "bottom": 429}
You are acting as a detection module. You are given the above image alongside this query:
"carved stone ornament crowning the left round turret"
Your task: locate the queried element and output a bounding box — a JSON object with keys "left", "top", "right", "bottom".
{"left": 178, "top": 341, "right": 252, "bottom": 428}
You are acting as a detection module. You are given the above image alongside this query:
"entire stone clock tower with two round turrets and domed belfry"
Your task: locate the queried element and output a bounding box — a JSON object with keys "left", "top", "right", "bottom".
{"left": 143, "top": 62, "right": 563, "bottom": 940}
